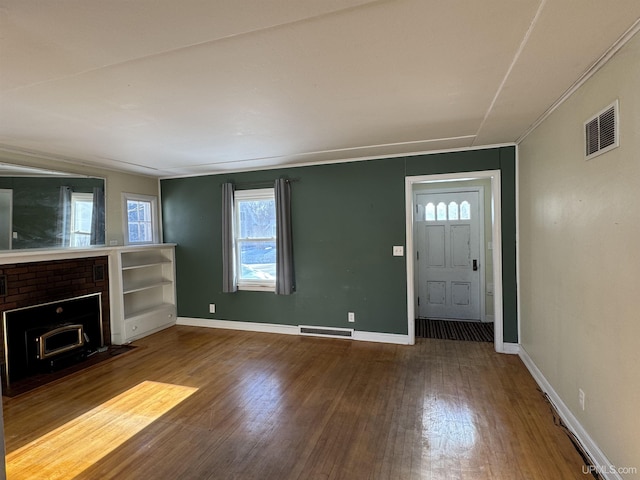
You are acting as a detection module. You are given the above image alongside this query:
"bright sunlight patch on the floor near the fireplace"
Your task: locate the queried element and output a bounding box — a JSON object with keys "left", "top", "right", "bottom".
{"left": 6, "top": 381, "right": 198, "bottom": 480}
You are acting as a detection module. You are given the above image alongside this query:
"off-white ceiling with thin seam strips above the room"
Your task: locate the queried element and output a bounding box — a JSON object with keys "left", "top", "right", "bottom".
{"left": 0, "top": 0, "right": 640, "bottom": 176}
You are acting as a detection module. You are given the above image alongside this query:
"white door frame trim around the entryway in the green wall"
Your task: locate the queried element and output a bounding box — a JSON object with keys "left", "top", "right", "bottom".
{"left": 405, "top": 170, "right": 506, "bottom": 353}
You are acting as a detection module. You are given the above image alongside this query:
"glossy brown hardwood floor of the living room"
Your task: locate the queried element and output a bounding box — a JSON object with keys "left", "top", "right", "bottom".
{"left": 3, "top": 327, "right": 586, "bottom": 480}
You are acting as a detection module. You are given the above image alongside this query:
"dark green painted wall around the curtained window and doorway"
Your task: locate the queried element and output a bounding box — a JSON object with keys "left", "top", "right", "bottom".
{"left": 161, "top": 147, "right": 517, "bottom": 342}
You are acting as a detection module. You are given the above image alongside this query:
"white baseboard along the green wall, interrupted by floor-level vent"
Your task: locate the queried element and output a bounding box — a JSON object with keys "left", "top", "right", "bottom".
{"left": 176, "top": 317, "right": 409, "bottom": 345}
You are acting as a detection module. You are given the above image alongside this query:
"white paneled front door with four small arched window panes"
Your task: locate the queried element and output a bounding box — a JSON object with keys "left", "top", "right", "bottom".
{"left": 415, "top": 191, "right": 483, "bottom": 320}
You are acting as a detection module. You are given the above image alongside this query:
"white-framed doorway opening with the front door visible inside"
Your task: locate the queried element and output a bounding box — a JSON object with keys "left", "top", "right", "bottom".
{"left": 406, "top": 170, "right": 504, "bottom": 352}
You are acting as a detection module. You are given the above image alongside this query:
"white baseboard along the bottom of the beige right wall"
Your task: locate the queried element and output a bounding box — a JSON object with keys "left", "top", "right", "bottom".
{"left": 519, "top": 346, "right": 622, "bottom": 480}
